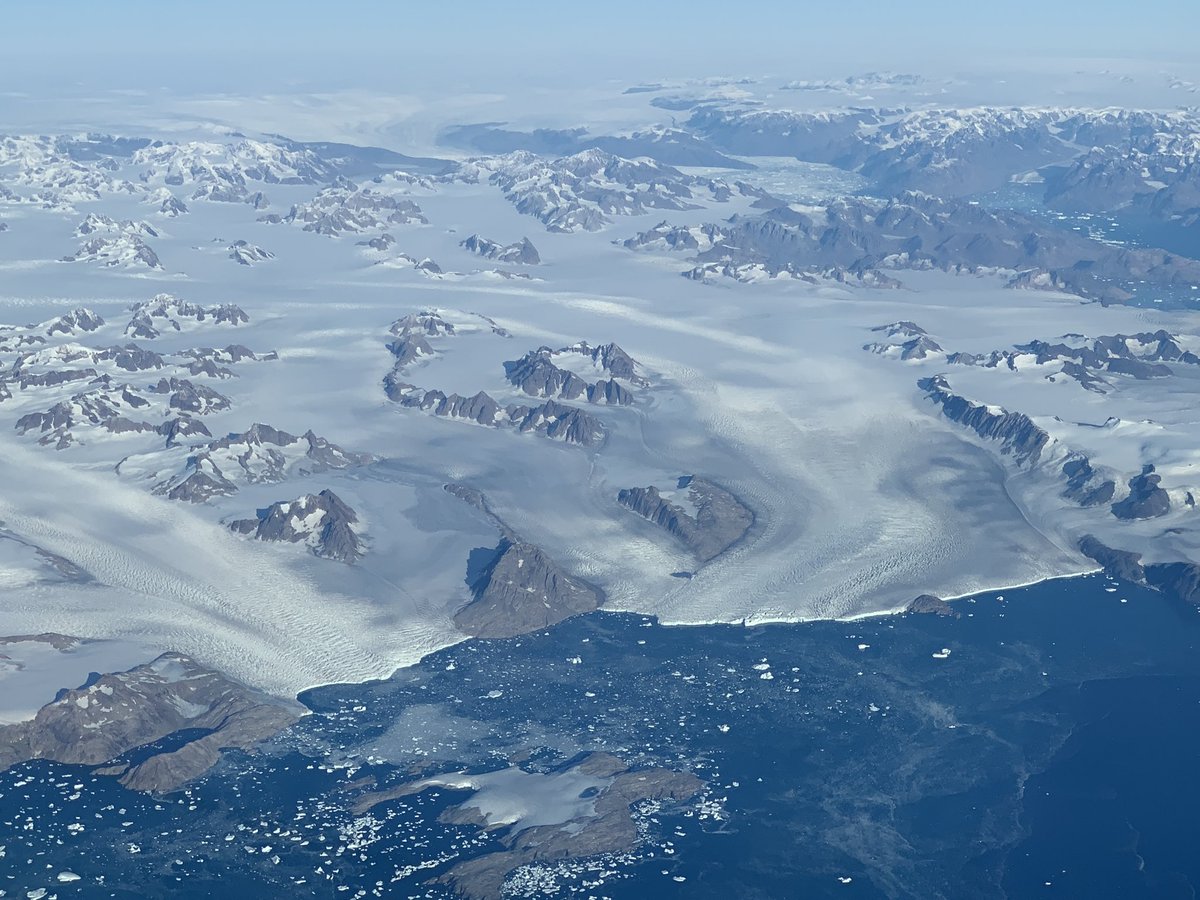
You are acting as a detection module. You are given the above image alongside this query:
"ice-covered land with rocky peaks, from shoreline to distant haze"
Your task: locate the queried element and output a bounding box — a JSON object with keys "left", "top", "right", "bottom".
{"left": 7, "top": 109, "right": 1200, "bottom": 788}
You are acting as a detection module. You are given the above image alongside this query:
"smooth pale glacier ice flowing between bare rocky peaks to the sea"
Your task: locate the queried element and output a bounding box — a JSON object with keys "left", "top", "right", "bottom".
{"left": 0, "top": 132, "right": 1195, "bottom": 694}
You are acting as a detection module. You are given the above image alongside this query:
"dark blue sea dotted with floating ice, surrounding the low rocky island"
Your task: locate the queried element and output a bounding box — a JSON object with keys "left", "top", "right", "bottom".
{"left": 0, "top": 576, "right": 1200, "bottom": 900}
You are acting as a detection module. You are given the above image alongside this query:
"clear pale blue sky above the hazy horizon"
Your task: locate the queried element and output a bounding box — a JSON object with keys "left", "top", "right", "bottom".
{"left": 9, "top": 0, "right": 1200, "bottom": 90}
